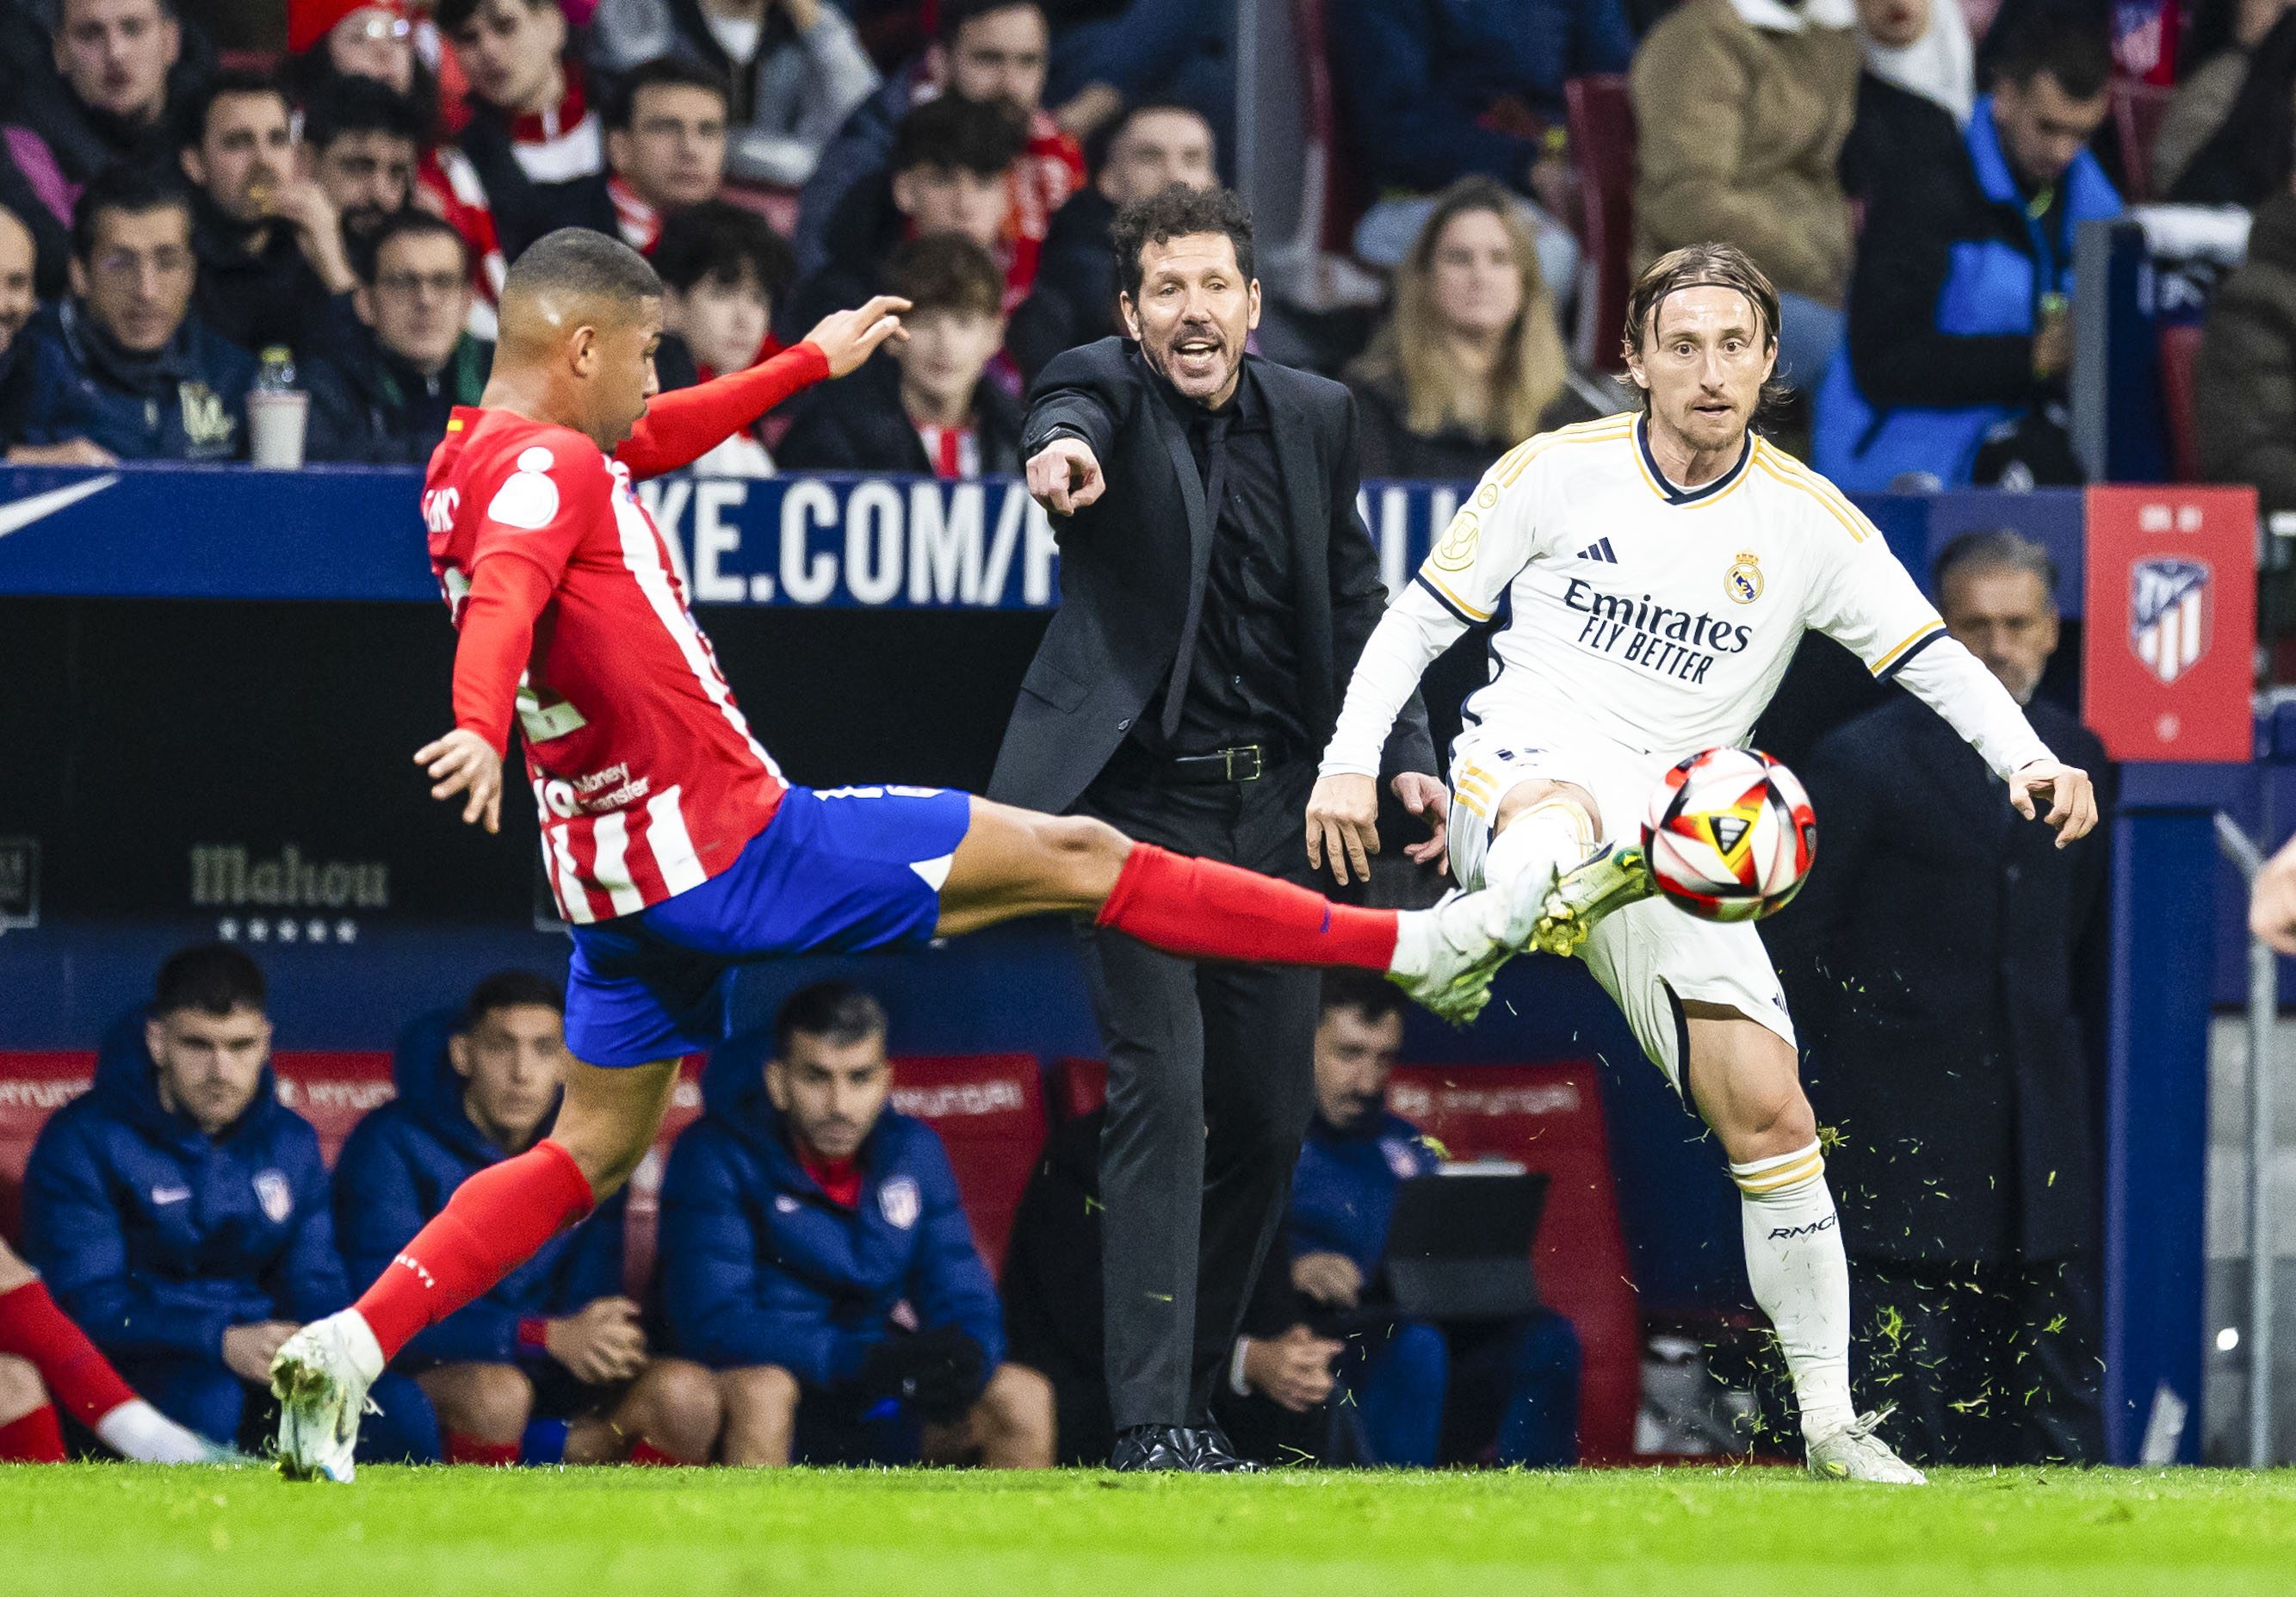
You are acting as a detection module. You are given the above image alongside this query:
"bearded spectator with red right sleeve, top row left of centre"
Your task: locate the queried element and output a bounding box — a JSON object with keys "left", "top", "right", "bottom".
{"left": 792, "top": 0, "right": 1084, "bottom": 298}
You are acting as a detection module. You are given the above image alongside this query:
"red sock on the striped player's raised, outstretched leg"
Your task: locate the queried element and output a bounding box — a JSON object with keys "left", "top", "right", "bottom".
{"left": 1099, "top": 842, "right": 1396, "bottom": 970}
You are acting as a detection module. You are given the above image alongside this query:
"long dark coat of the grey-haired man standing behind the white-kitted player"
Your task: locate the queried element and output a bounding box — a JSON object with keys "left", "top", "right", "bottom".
{"left": 1766, "top": 696, "right": 2113, "bottom": 1262}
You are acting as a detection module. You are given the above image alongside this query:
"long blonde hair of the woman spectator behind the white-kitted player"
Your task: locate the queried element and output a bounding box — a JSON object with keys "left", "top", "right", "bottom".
{"left": 1357, "top": 176, "right": 1569, "bottom": 441}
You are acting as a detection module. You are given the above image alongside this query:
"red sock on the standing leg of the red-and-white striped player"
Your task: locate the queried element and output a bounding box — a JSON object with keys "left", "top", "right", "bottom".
{"left": 354, "top": 1138, "right": 595, "bottom": 1359}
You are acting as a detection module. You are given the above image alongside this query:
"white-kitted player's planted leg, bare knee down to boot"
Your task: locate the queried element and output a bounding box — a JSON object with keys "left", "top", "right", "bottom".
{"left": 1683, "top": 1000, "right": 1922, "bottom": 1484}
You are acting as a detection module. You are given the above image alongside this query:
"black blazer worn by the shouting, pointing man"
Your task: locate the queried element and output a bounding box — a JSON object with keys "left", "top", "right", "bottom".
{"left": 989, "top": 337, "right": 1435, "bottom": 814}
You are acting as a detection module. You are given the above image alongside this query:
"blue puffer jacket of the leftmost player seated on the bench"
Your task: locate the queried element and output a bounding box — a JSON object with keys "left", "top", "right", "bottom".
{"left": 23, "top": 1014, "right": 349, "bottom": 1363}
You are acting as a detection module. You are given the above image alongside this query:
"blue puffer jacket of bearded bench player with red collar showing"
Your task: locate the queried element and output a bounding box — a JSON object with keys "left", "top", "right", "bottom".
{"left": 661, "top": 1044, "right": 1003, "bottom": 1388}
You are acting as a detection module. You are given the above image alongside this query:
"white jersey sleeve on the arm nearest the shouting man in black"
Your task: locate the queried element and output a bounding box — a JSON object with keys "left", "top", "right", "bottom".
{"left": 1318, "top": 445, "right": 1545, "bottom": 778}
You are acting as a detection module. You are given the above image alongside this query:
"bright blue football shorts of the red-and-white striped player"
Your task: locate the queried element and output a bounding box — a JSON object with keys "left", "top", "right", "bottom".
{"left": 567, "top": 787, "right": 971, "bottom": 1069}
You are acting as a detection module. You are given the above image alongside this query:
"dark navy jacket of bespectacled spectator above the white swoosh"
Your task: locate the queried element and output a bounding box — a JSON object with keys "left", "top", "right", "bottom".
{"left": 0, "top": 298, "right": 257, "bottom": 461}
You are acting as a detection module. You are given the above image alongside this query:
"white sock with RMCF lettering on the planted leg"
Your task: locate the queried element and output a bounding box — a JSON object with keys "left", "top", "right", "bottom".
{"left": 1729, "top": 1141, "right": 1858, "bottom": 1436}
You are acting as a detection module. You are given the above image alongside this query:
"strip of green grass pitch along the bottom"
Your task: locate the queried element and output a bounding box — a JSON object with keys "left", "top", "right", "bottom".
{"left": 0, "top": 1464, "right": 2296, "bottom": 1597}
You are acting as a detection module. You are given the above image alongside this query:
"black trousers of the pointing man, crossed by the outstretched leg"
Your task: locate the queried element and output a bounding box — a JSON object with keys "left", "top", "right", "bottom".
{"left": 1081, "top": 755, "right": 1322, "bottom": 1429}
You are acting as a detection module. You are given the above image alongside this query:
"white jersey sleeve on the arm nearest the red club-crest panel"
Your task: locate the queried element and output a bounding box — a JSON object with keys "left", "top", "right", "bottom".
{"left": 1807, "top": 493, "right": 2051, "bottom": 780}
